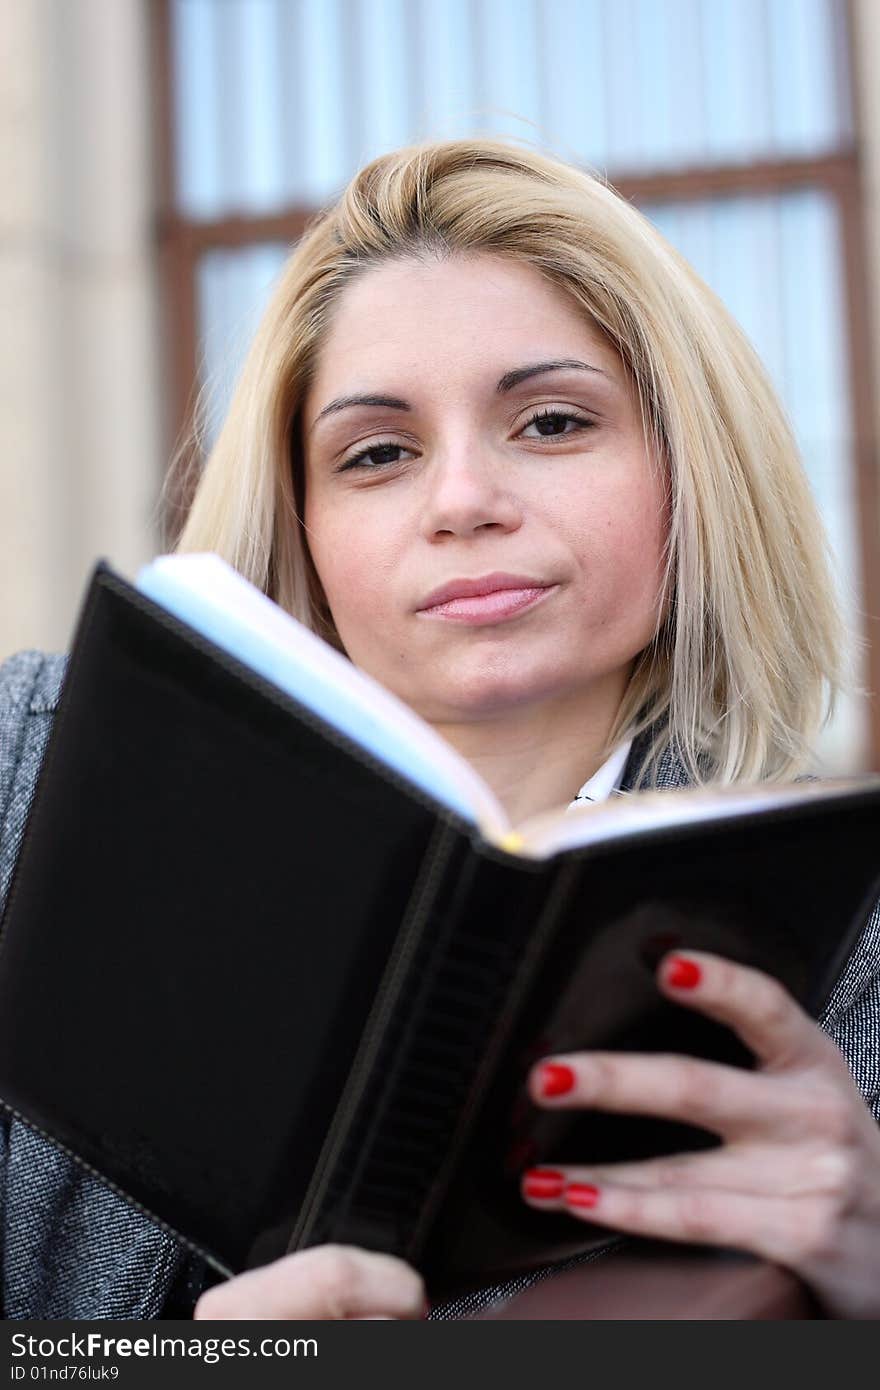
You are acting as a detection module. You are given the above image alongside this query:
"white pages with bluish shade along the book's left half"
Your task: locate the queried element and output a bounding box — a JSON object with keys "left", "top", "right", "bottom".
{"left": 135, "top": 553, "right": 510, "bottom": 842}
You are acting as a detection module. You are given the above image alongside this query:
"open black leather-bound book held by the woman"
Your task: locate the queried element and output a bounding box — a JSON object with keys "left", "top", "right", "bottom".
{"left": 0, "top": 556, "right": 880, "bottom": 1297}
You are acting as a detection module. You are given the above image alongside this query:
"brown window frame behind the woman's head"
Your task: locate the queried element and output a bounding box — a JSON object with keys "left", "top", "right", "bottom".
{"left": 150, "top": 0, "right": 880, "bottom": 771}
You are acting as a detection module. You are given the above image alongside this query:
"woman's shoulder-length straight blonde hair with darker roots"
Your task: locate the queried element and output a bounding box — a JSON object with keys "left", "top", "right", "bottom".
{"left": 177, "top": 139, "right": 845, "bottom": 783}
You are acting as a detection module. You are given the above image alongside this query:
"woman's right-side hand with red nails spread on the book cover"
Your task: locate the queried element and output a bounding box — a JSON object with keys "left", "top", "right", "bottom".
{"left": 523, "top": 952, "right": 880, "bottom": 1318}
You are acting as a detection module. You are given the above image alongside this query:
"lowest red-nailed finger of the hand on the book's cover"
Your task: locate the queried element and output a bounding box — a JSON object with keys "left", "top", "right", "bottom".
{"left": 560, "top": 1183, "right": 801, "bottom": 1264}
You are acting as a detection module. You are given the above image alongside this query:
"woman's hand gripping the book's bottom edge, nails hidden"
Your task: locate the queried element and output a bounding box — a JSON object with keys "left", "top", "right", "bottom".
{"left": 193, "top": 1245, "right": 427, "bottom": 1321}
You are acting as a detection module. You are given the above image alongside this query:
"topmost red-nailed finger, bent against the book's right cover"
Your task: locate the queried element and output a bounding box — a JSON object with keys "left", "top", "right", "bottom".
{"left": 658, "top": 951, "right": 831, "bottom": 1070}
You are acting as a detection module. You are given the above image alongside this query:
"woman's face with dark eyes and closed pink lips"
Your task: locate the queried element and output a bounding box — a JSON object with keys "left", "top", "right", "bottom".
{"left": 302, "top": 254, "right": 666, "bottom": 724}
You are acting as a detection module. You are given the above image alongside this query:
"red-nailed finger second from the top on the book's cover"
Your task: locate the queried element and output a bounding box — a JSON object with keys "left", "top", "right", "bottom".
{"left": 528, "top": 1052, "right": 809, "bottom": 1140}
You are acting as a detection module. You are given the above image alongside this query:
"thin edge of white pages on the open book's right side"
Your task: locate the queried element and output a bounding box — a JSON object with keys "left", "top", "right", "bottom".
{"left": 514, "top": 776, "right": 880, "bottom": 859}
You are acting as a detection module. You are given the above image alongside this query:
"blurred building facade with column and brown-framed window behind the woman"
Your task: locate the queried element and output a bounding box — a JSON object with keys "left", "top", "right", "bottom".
{"left": 0, "top": 0, "right": 880, "bottom": 770}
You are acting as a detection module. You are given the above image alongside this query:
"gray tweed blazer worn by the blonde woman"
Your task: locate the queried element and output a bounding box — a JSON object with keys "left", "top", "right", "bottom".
{"left": 0, "top": 652, "right": 880, "bottom": 1319}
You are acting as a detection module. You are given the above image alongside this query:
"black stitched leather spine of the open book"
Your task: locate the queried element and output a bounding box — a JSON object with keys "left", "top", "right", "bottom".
{"left": 292, "top": 835, "right": 572, "bottom": 1258}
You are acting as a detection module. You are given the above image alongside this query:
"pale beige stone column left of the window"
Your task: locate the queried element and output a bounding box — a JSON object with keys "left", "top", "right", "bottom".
{"left": 0, "top": 0, "right": 161, "bottom": 660}
